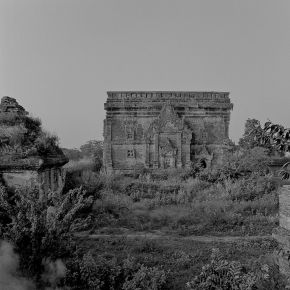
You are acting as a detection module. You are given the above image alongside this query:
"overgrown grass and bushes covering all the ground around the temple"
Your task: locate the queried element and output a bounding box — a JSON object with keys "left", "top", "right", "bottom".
{"left": 0, "top": 120, "right": 285, "bottom": 290}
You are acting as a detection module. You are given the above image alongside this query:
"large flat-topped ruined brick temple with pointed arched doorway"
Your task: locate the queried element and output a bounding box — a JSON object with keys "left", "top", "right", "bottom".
{"left": 104, "top": 91, "right": 233, "bottom": 172}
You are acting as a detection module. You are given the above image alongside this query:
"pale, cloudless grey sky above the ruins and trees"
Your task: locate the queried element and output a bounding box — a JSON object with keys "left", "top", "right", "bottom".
{"left": 0, "top": 0, "right": 290, "bottom": 148}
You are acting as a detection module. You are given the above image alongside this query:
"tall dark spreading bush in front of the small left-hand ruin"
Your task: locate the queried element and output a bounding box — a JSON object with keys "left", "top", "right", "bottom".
{"left": 0, "top": 188, "right": 92, "bottom": 284}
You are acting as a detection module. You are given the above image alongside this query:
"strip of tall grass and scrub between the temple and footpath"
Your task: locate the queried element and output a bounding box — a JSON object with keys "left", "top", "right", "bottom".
{"left": 76, "top": 148, "right": 278, "bottom": 236}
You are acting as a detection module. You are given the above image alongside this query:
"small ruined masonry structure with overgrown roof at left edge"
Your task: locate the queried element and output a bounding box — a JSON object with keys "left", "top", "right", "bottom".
{"left": 0, "top": 97, "right": 68, "bottom": 192}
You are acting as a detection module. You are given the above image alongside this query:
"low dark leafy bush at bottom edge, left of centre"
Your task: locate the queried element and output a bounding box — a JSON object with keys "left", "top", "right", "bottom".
{"left": 65, "top": 252, "right": 166, "bottom": 290}
